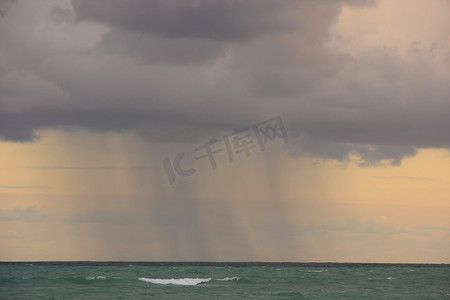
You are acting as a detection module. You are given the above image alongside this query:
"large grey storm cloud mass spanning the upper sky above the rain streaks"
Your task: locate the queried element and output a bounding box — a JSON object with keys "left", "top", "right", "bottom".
{"left": 0, "top": 0, "right": 450, "bottom": 165}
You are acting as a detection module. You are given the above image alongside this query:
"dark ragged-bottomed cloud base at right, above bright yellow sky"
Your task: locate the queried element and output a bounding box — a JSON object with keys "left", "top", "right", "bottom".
{"left": 288, "top": 105, "right": 450, "bottom": 166}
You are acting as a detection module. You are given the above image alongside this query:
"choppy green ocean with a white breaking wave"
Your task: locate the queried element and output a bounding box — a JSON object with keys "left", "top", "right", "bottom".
{"left": 0, "top": 262, "right": 450, "bottom": 299}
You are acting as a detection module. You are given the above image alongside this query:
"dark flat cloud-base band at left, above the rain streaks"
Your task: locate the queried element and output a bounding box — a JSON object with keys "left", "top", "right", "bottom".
{"left": 0, "top": 108, "right": 236, "bottom": 142}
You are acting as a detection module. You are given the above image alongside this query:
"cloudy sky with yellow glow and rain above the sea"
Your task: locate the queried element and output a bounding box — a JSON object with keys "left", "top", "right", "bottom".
{"left": 0, "top": 0, "right": 450, "bottom": 263}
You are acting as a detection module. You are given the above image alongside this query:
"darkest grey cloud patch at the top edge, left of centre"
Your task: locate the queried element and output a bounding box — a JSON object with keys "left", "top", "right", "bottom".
{"left": 73, "top": 0, "right": 298, "bottom": 64}
